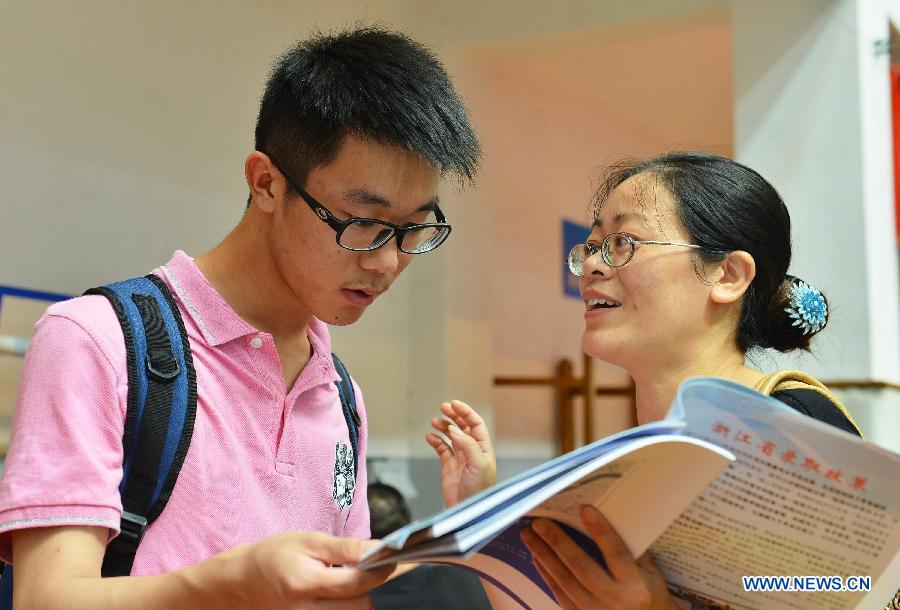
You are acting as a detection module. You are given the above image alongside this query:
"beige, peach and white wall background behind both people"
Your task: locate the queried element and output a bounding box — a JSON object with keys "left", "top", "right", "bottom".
{"left": 0, "top": 0, "right": 898, "bottom": 508}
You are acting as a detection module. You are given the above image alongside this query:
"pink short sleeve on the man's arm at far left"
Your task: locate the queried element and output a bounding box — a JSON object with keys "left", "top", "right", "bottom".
{"left": 0, "top": 297, "right": 127, "bottom": 561}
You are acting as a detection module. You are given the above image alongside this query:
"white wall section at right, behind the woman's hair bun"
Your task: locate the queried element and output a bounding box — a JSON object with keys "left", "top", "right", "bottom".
{"left": 732, "top": 0, "right": 900, "bottom": 383}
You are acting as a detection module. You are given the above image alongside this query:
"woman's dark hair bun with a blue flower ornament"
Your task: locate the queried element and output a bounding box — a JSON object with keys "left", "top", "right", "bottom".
{"left": 771, "top": 275, "right": 828, "bottom": 352}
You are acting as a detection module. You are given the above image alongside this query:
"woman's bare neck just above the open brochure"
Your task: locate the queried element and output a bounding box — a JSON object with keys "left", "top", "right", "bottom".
{"left": 629, "top": 346, "right": 763, "bottom": 424}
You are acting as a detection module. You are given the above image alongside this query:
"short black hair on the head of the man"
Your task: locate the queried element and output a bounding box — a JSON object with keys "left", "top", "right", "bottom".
{"left": 256, "top": 27, "right": 481, "bottom": 190}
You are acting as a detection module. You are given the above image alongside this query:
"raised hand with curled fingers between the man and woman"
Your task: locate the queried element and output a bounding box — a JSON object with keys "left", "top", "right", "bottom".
{"left": 425, "top": 400, "right": 497, "bottom": 508}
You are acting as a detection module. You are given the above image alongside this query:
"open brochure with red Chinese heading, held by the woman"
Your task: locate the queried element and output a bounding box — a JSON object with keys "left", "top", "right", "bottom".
{"left": 360, "top": 378, "right": 900, "bottom": 610}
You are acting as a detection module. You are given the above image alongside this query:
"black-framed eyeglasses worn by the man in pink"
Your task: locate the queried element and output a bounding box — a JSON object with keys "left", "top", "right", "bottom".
{"left": 260, "top": 151, "right": 452, "bottom": 254}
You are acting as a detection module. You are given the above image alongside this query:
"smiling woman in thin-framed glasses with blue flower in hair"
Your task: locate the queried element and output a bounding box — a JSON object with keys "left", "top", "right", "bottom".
{"left": 522, "top": 152, "right": 859, "bottom": 610}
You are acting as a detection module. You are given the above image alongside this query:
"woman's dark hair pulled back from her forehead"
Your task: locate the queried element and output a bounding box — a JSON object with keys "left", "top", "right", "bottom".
{"left": 594, "top": 152, "right": 824, "bottom": 353}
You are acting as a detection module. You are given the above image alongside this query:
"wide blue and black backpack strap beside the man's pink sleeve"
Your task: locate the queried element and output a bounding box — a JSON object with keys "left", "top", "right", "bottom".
{"left": 85, "top": 275, "right": 197, "bottom": 576}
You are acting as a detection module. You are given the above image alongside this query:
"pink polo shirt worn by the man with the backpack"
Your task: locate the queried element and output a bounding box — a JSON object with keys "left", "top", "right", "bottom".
{"left": 0, "top": 251, "right": 369, "bottom": 575}
